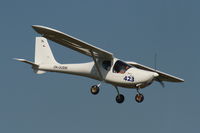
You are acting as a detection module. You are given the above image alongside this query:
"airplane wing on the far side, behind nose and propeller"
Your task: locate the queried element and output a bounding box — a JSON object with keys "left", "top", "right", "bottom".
{"left": 127, "top": 62, "right": 184, "bottom": 82}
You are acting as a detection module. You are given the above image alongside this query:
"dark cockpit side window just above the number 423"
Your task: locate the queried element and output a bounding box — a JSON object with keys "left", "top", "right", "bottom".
{"left": 113, "top": 60, "right": 131, "bottom": 74}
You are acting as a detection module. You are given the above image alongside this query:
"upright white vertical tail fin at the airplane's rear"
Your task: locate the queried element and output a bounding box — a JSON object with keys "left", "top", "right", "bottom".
{"left": 35, "top": 37, "right": 58, "bottom": 65}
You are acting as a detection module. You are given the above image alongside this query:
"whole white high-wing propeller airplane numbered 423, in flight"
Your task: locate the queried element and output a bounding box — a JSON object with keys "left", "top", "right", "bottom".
{"left": 15, "top": 25, "right": 184, "bottom": 103}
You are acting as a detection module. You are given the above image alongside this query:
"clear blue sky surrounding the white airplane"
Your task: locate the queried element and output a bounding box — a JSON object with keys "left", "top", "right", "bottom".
{"left": 0, "top": 0, "right": 200, "bottom": 133}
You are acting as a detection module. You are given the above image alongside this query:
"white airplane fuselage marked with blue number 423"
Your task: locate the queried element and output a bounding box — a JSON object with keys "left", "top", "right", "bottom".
{"left": 37, "top": 59, "right": 158, "bottom": 88}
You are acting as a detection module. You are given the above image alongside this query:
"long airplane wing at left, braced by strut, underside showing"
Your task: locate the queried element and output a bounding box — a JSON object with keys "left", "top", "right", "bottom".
{"left": 32, "top": 25, "right": 113, "bottom": 59}
